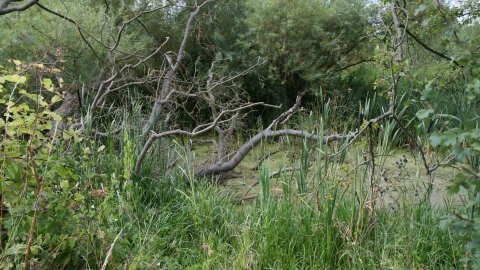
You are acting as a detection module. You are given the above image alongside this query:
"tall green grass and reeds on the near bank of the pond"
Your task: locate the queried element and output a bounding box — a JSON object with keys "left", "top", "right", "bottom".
{"left": 0, "top": 130, "right": 465, "bottom": 269}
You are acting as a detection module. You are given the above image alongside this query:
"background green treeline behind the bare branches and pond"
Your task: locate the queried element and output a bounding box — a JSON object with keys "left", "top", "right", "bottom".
{"left": 0, "top": 0, "right": 446, "bottom": 131}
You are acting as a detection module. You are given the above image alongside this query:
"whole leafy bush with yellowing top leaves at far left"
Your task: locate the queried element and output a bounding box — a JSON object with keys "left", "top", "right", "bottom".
{"left": 0, "top": 60, "right": 105, "bottom": 269}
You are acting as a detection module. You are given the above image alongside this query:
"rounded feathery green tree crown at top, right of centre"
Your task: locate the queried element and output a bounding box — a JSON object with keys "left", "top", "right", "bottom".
{"left": 247, "top": 0, "right": 368, "bottom": 82}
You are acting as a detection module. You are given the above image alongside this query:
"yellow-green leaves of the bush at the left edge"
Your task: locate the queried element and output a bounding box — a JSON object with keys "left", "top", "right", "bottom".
{"left": 0, "top": 60, "right": 86, "bottom": 265}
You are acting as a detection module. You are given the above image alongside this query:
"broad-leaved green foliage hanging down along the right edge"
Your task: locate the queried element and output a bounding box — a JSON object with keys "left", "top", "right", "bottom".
{"left": 404, "top": 0, "right": 480, "bottom": 268}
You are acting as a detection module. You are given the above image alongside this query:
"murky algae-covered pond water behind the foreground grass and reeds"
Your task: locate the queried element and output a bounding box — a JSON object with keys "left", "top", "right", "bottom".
{"left": 188, "top": 139, "right": 465, "bottom": 206}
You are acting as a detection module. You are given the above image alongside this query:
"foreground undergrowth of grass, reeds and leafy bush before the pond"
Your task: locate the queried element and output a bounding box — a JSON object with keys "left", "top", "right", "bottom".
{"left": 0, "top": 84, "right": 465, "bottom": 269}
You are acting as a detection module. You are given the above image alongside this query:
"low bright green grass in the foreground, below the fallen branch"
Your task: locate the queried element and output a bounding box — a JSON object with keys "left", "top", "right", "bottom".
{"left": 109, "top": 172, "right": 462, "bottom": 269}
